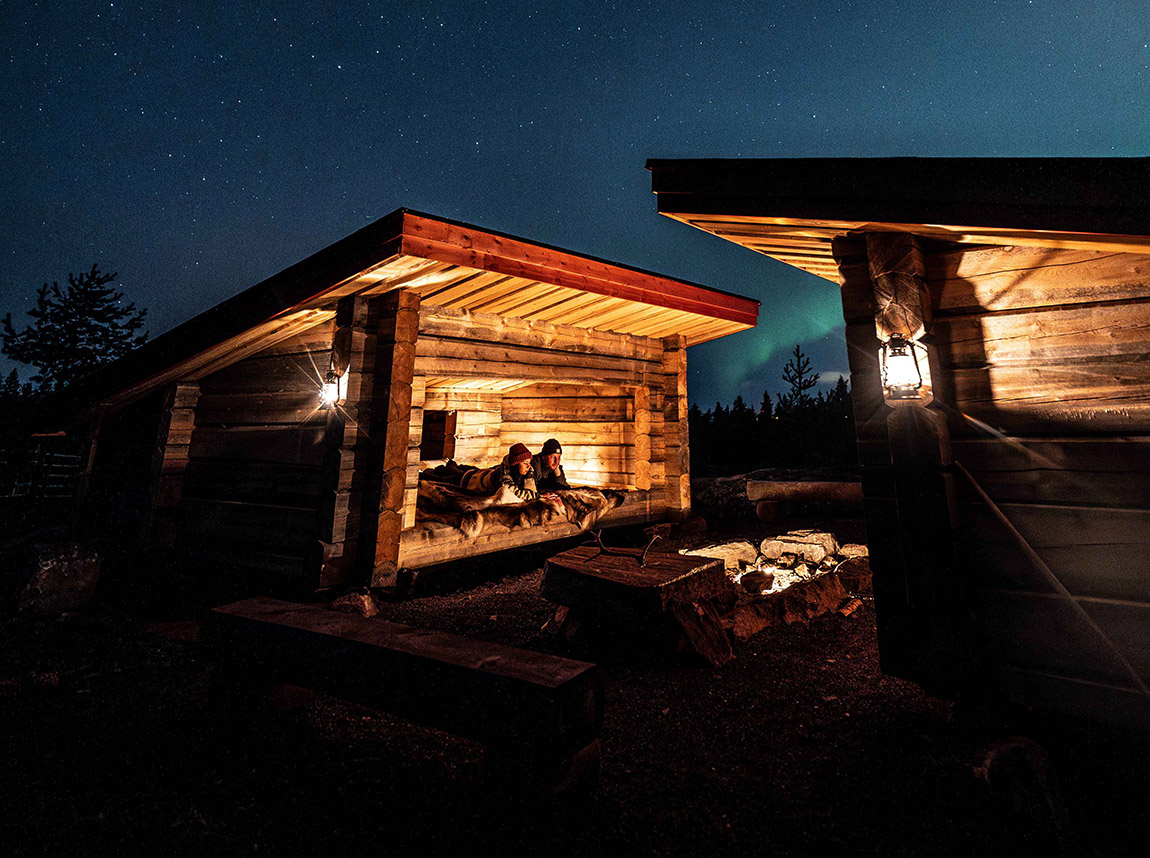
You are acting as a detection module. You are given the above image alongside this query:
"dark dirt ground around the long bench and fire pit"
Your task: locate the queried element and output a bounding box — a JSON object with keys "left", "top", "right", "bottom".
{"left": 0, "top": 499, "right": 1150, "bottom": 858}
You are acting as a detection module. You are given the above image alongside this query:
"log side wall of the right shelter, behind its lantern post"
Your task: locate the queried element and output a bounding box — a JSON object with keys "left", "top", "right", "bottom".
{"left": 837, "top": 236, "right": 1150, "bottom": 726}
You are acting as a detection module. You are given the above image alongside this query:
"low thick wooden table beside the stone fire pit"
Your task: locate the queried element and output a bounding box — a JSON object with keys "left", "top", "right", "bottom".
{"left": 541, "top": 544, "right": 735, "bottom": 667}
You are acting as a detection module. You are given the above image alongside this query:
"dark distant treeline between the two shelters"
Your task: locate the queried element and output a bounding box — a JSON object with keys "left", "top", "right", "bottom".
{"left": 688, "top": 346, "right": 858, "bottom": 476}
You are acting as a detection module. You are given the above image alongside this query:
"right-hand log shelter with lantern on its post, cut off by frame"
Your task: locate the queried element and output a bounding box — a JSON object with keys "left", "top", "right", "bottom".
{"left": 649, "top": 159, "right": 1150, "bottom": 727}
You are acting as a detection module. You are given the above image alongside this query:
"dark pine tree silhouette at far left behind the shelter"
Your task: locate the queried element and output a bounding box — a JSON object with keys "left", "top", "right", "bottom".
{"left": 0, "top": 265, "right": 147, "bottom": 392}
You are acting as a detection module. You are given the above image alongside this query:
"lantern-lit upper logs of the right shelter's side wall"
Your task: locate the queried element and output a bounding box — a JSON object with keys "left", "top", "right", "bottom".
{"left": 928, "top": 247, "right": 1150, "bottom": 436}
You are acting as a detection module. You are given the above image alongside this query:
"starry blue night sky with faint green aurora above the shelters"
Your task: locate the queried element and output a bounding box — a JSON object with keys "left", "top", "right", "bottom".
{"left": 0, "top": 0, "right": 1150, "bottom": 408}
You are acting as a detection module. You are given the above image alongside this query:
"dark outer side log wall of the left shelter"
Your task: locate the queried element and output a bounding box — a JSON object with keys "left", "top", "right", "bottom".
{"left": 178, "top": 323, "right": 334, "bottom": 588}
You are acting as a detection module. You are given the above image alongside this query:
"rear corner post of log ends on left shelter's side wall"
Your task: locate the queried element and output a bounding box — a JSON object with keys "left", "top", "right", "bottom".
{"left": 151, "top": 382, "right": 200, "bottom": 547}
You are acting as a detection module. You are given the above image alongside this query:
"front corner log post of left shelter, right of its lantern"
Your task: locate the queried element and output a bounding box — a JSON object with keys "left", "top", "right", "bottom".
{"left": 323, "top": 290, "right": 422, "bottom": 587}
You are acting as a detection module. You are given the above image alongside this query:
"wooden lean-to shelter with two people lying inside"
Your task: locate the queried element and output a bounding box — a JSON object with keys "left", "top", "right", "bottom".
{"left": 72, "top": 209, "right": 758, "bottom": 589}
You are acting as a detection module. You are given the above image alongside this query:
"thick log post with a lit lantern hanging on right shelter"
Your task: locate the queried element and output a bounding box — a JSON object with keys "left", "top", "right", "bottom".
{"left": 834, "top": 232, "right": 966, "bottom": 696}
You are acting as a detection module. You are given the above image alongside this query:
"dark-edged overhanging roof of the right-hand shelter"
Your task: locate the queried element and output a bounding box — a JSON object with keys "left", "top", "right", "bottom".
{"left": 647, "top": 158, "right": 1150, "bottom": 283}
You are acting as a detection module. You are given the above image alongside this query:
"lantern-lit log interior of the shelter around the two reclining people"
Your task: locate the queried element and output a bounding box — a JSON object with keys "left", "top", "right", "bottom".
{"left": 399, "top": 306, "right": 690, "bottom": 568}
